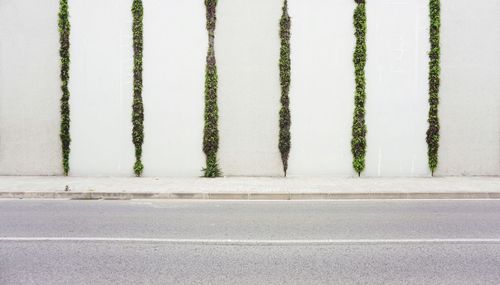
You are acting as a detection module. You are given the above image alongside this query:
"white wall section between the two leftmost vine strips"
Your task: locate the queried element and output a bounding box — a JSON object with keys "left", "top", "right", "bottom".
{"left": 69, "top": 0, "right": 134, "bottom": 176}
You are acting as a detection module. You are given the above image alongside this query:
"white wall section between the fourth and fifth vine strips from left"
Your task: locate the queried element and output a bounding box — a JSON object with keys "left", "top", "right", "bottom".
{"left": 289, "top": 0, "right": 355, "bottom": 176}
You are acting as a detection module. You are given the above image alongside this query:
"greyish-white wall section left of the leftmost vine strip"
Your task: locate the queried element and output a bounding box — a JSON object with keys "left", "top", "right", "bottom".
{"left": 0, "top": 0, "right": 62, "bottom": 175}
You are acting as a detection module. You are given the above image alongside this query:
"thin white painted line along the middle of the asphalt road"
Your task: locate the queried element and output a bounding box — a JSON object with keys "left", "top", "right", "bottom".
{"left": 0, "top": 237, "right": 500, "bottom": 246}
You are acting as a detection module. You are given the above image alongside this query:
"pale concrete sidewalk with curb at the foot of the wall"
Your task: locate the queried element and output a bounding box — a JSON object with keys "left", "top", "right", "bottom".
{"left": 0, "top": 176, "right": 500, "bottom": 200}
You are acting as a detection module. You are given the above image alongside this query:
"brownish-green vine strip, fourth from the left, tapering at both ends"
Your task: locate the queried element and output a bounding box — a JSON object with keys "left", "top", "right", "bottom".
{"left": 279, "top": 0, "right": 291, "bottom": 177}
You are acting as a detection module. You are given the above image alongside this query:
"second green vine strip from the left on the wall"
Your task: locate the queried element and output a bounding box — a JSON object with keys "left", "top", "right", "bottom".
{"left": 132, "top": 0, "right": 144, "bottom": 176}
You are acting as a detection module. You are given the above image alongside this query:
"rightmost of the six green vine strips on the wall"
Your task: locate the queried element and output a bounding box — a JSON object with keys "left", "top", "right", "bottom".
{"left": 426, "top": 0, "right": 441, "bottom": 176}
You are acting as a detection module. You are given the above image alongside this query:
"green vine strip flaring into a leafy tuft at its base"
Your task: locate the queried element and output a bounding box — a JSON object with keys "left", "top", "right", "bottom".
{"left": 203, "top": 0, "right": 222, "bottom": 177}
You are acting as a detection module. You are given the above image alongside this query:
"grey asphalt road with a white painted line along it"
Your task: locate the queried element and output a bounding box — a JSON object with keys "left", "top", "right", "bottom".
{"left": 0, "top": 200, "right": 500, "bottom": 285}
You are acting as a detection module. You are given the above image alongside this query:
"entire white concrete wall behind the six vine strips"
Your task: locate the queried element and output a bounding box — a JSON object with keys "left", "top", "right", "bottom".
{"left": 0, "top": 0, "right": 500, "bottom": 176}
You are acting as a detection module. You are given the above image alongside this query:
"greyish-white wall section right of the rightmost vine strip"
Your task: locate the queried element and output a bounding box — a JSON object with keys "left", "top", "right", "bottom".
{"left": 438, "top": 0, "right": 500, "bottom": 175}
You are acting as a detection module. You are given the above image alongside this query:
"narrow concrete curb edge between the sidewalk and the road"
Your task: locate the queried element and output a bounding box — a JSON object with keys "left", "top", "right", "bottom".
{"left": 0, "top": 192, "right": 500, "bottom": 201}
